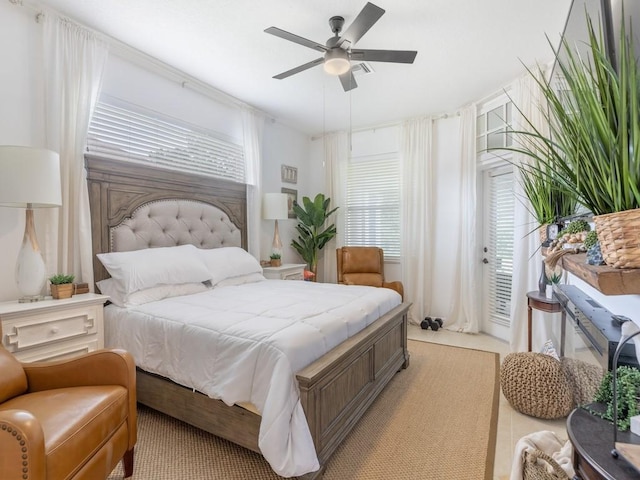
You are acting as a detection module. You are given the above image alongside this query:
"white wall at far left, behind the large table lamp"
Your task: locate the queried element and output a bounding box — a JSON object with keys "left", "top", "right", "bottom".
{"left": 0, "top": 2, "right": 44, "bottom": 301}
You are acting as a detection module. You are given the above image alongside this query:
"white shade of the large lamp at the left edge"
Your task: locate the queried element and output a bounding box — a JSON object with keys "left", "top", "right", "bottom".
{"left": 0, "top": 146, "right": 62, "bottom": 208}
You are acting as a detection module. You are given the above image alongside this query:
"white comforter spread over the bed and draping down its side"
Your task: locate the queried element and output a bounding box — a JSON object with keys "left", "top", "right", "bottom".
{"left": 105, "top": 280, "right": 401, "bottom": 477}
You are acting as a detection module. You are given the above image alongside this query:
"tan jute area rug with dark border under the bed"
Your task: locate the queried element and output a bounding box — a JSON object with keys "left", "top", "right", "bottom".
{"left": 109, "top": 340, "right": 500, "bottom": 480}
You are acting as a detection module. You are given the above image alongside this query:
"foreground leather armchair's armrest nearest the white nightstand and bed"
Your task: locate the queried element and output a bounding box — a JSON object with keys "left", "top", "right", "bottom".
{"left": 22, "top": 349, "right": 137, "bottom": 448}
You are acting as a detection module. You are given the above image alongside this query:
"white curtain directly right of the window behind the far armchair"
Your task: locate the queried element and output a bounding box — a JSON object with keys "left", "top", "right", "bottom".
{"left": 400, "top": 117, "right": 436, "bottom": 324}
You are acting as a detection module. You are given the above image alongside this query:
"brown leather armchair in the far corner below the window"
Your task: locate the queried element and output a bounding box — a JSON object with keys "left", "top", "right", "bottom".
{"left": 336, "top": 247, "right": 404, "bottom": 298}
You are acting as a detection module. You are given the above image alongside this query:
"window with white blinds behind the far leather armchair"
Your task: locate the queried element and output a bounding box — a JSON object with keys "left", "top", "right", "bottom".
{"left": 344, "top": 156, "right": 400, "bottom": 258}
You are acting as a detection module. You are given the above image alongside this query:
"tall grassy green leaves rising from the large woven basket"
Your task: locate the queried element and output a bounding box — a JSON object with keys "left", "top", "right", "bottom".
{"left": 508, "top": 15, "right": 640, "bottom": 215}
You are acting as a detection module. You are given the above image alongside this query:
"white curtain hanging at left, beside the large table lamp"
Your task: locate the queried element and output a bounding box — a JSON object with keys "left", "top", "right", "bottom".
{"left": 43, "top": 13, "right": 108, "bottom": 287}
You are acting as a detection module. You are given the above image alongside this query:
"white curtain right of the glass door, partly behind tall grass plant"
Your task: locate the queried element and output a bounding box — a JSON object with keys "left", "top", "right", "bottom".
{"left": 510, "top": 72, "right": 570, "bottom": 352}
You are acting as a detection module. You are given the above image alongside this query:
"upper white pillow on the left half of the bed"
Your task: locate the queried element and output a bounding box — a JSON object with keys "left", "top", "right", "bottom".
{"left": 97, "top": 245, "right": 211, "bottom": 295}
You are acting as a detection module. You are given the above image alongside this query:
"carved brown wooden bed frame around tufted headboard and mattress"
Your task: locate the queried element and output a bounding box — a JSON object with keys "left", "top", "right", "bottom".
{"left": 86, "top": 156, "right": 409, "bottom": 479}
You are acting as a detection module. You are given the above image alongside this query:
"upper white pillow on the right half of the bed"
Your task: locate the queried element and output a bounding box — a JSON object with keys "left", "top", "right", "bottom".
{"left": 198, "top": 247, "right": 262, "bottom": 286}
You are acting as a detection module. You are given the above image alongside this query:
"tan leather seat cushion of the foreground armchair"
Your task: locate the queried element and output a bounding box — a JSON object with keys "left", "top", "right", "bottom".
{"left": 0, "top": 385, "right": 128, "bottom": 478}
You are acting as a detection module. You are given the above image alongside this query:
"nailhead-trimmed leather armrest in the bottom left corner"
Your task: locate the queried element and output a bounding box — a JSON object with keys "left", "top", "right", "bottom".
{"left": 0, "top": 410, "right": 46, "bottom": 480}
